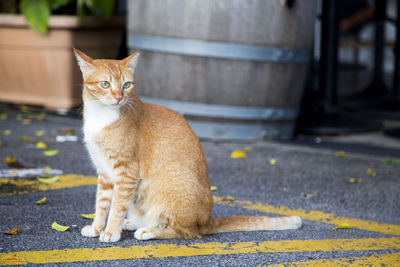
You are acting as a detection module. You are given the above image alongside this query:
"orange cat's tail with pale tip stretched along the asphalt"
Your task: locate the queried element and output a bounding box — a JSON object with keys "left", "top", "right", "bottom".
{"left": 206, "top": 216, "right": 301, "bottom": 234}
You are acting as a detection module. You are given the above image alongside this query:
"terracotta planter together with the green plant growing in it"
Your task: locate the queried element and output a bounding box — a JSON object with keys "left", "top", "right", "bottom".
{"left": 0, "top": 0, "right": 125, "bottom": 110}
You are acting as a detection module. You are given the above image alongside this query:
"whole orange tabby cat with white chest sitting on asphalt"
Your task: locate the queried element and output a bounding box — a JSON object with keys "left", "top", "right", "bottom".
{"left": 75, "top": 49, "right": 301, "bottom": 242}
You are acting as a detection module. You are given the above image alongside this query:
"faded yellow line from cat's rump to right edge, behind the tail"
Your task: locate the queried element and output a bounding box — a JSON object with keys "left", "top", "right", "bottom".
{"left": 214, "top": 197, "right": 400, "bottom": 238}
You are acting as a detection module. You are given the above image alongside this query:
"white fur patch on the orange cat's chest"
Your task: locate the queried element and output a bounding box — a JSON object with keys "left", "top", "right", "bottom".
{"left": 83, "top": 101, "right": 119, "bottom": 181}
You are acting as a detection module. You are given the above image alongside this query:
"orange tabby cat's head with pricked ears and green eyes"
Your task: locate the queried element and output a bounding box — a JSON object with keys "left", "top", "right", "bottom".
{"left": 74, "top": 48, "right": 139, "bottom": 108}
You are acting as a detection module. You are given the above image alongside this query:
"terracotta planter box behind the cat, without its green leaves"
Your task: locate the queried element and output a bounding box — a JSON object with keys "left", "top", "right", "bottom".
{"left": 0, "top": 15, "right": 125, "bottom": 110}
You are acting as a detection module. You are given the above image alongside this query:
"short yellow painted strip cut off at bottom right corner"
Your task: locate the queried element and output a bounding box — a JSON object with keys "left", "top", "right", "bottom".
{"left": 268, "top": 252, "right": 400, "bottom": 267}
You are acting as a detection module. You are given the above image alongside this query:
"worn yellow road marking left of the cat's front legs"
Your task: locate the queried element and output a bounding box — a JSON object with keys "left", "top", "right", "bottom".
{"left": 0, "top": 174, "right": 97, "bottom": 196}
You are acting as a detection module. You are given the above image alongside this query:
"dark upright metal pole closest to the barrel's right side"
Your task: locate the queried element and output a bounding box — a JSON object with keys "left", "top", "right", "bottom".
{"left": 320, "top": 0, "right": 340, "bottom": 113}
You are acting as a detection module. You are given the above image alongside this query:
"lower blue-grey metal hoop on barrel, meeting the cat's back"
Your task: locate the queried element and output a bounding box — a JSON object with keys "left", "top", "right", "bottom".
{"left": 140, "top": 96, "right": 298, "bottom": 121}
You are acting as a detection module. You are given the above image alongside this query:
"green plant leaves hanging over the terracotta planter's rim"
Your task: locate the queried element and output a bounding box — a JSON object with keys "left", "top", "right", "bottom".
{"left": 19, "top": 0, "right": 115, "bottom": 34}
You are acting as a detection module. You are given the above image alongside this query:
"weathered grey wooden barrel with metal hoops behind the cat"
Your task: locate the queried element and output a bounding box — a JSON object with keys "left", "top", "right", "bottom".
{"left": 128, "top": 0, "right": 316, "bottom": 140}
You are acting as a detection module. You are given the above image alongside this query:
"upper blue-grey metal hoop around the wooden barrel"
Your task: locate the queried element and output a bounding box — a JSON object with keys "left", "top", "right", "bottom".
{"left": 128, "top": 33, "right": 311, "bottom": 63}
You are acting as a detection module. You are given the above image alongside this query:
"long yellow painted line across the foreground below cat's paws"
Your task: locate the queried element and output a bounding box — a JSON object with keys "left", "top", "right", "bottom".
{"left": 0, "top": 237, "right": 400, "bottom": 265}
